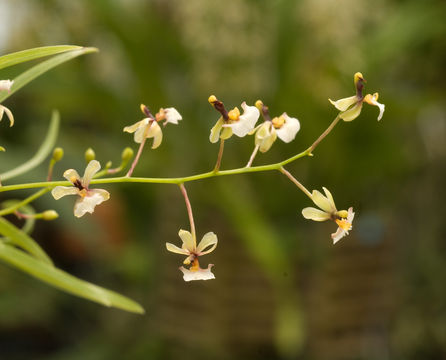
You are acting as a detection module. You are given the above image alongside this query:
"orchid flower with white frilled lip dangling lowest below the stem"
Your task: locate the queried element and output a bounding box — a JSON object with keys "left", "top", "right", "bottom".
{"left": 166, "top": 230, "right": 218, "bottom": 281}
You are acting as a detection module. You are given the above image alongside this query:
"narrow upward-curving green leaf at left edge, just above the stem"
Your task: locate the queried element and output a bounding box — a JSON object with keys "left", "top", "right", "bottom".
{"left": 0, "top": 110, "right": 60, "bottom": 181}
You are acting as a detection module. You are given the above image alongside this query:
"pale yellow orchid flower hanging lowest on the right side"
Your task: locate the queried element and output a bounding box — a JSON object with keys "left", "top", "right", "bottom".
{"left": 302, "top": 188, "right": 355, "bottom": 244}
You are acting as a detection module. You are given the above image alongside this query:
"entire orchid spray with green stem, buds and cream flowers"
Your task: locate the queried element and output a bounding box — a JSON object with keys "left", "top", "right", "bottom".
{"left": 0, "top": 65, "right": 384, "bottom": 312}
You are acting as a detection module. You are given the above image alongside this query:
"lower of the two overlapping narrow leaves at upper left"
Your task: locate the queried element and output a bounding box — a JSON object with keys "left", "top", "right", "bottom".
{"left": 0, "top": 48, "right": 98, "bottom": 103}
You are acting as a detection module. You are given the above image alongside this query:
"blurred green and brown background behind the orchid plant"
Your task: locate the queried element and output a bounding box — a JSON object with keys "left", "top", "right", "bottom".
{"left": 0, "top": 0, "right": 446, "bottom": 360}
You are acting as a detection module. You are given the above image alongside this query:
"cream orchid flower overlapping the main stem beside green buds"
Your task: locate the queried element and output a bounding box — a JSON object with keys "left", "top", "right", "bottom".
{"left": 51, "top": 160, "right": 110, "bottom": 217}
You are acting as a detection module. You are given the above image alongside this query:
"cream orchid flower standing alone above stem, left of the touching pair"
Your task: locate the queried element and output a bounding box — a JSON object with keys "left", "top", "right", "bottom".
{"left": 124, "top": 104, "right": 182, "bottom": 149}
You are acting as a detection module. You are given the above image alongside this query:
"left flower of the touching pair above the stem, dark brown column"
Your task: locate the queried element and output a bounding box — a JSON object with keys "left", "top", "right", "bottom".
{"left": 208, "top": 95, "right": 260, "bottom": 143}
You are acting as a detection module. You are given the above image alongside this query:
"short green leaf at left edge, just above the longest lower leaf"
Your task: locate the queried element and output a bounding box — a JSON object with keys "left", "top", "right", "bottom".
{"left": 0, "top": 217, "right": 53, "bottom": 266}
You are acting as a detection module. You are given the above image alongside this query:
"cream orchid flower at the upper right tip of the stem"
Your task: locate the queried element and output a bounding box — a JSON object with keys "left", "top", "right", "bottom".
{"left": 328, "top": 72, "right": 385, "bottom": 121}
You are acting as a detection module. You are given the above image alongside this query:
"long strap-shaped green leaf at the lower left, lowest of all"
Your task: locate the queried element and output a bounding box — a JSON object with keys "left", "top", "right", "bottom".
{"left": 0, "top": 243, "right": 144, "bottom": 314}
